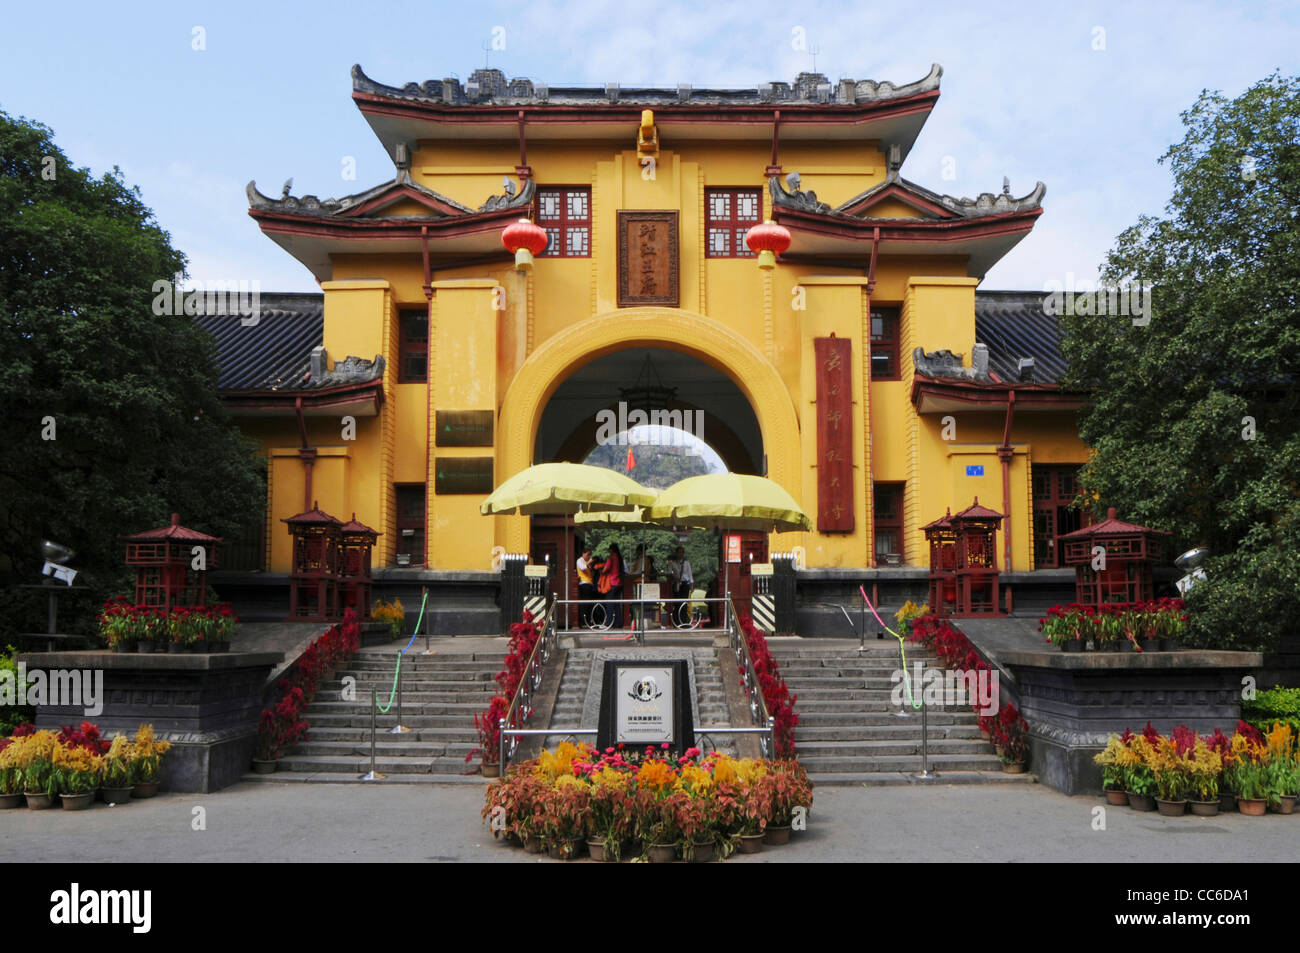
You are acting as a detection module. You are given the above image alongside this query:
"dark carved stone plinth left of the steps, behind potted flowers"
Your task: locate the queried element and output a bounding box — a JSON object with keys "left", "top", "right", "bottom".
{"left": 18, "top": 651, "right": 283, "bottom": 793}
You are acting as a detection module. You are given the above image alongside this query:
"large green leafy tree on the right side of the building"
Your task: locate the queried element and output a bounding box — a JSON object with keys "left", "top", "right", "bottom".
{"left": 1063, "top": 74, "right": 1300, "bottom": 647}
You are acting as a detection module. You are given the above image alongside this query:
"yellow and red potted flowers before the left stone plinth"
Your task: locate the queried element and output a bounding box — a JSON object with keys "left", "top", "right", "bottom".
{"left": 0, "top": 722, "right": 172, "bottom": 807}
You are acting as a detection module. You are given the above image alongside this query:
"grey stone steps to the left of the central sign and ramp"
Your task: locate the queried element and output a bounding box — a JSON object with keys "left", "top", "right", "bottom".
{"left": 247, "top": 638, "right": 506, "bottom": 784}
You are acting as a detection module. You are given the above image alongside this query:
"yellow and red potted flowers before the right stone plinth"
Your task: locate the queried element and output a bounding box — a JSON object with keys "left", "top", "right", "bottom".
{"left": 1093, "top": 722, "right": 1300, "bottom": 814}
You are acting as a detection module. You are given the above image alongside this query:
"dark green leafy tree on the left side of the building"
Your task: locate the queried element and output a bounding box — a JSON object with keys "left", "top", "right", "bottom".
{"left": 0, "top": 112, "right": 263, "bottom": 631}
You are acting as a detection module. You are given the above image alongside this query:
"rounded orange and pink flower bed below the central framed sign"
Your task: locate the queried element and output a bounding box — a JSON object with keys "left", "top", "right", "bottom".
{"left": 482, "top": 742, "right": 813, "bottom": 861}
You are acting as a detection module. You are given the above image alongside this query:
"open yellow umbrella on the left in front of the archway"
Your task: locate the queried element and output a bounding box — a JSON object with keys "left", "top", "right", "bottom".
{"left": 478, "top": 463, "right": 657, "bottom": 516}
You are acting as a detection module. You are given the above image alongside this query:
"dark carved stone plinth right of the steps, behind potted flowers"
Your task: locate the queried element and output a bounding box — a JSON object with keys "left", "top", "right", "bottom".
{"left": 997, "top": 649, "right": 1262, "bottom": 794}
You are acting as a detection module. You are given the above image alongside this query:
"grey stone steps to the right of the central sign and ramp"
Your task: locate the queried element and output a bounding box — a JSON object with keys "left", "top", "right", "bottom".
{"left": 770, "top": 638, "right": 1034, "bottom": 785}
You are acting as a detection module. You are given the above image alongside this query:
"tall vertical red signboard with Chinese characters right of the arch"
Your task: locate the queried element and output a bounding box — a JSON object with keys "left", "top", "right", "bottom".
{"left": 813, "top": 334, "right": 854, "bottom": 533}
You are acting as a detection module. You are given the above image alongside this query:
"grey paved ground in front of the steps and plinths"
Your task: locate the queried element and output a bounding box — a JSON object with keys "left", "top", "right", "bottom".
{"left": 0, "top": 783, "right": 1300, "bottom": 863}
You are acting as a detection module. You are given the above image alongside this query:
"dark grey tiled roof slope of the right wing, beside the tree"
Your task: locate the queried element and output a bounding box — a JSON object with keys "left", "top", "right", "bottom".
{"left": 975, "top": 291, "right": 1066, "bottom": 384}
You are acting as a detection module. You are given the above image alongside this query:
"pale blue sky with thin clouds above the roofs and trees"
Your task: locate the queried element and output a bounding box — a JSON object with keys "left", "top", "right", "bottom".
{"left": 0, "top": 0, "right": 1300, "bottom": 291}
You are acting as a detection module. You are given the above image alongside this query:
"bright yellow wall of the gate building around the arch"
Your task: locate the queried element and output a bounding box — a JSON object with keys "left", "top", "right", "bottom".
{"left": 246, "top": 129, "right": 1087, "bottom": 571}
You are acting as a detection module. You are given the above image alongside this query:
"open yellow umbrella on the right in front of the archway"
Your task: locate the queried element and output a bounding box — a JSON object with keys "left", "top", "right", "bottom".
{"left": 646, "top": 473, "right": 813, "bottom": 533}
